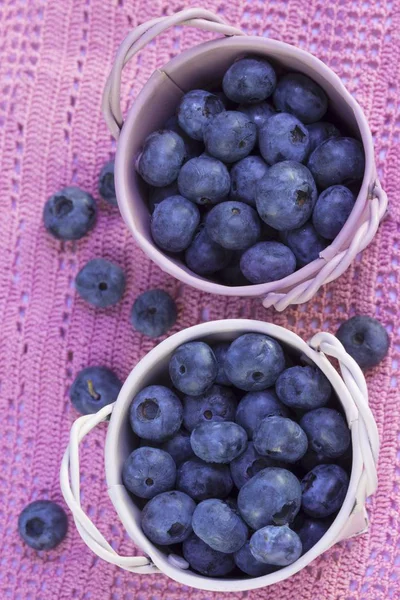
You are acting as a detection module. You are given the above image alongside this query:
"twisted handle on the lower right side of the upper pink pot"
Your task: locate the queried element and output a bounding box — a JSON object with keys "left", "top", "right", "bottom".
{"left": 263, "top": 180, "right": 388, "bottom": 311}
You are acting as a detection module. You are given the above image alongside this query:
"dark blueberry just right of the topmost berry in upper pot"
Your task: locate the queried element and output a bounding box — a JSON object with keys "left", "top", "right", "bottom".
{"left": 274, "top": 73, "right": 328, "bottom": 124}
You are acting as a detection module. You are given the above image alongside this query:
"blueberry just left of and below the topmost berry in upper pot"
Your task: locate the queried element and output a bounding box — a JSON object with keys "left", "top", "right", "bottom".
{"left": 178, "top": 90, "right": 225, "bottom": 140}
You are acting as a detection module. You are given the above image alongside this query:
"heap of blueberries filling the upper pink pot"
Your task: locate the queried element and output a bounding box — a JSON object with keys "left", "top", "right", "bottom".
{"left": 140, "top": 57, "right": 365, "bottom": 286}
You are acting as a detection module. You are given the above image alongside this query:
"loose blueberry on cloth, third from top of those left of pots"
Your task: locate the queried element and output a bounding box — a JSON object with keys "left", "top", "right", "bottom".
{"left": 75, "top": 258, "right": 125, "bottom": 308}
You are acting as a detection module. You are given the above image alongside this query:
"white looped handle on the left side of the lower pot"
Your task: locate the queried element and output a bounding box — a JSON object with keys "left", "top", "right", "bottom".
{"left": 60, "top": 404, "right": 159, "bottom": 574}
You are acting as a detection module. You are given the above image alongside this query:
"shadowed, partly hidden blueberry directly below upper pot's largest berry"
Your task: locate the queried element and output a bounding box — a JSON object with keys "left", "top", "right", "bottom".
{"left": 282, "top": 221, "right": 329, "bottom": 267}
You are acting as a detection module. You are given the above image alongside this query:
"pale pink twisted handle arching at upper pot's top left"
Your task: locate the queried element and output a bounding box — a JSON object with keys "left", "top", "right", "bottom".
{"left": 102, "top": 8, "right": 245, "bottom": 139}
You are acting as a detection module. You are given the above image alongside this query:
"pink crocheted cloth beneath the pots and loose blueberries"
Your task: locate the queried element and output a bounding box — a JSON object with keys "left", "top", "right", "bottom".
{"left": 0, "top": 0, "right": 400, "bottom": 600}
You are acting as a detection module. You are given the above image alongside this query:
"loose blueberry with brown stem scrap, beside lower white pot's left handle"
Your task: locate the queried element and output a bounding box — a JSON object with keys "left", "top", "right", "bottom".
{"left": 69, "top": 367, "right": 122, "bottom": 415}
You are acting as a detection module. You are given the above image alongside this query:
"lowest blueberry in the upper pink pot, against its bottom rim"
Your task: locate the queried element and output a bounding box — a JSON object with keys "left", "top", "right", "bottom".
{"left": 240, "top": 242, "right": 296, "bottom": 283}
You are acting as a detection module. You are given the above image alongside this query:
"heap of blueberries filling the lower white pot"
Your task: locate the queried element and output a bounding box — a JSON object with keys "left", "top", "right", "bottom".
{"left": 122, "top": 333, "right": 351, "bottom": 577}
